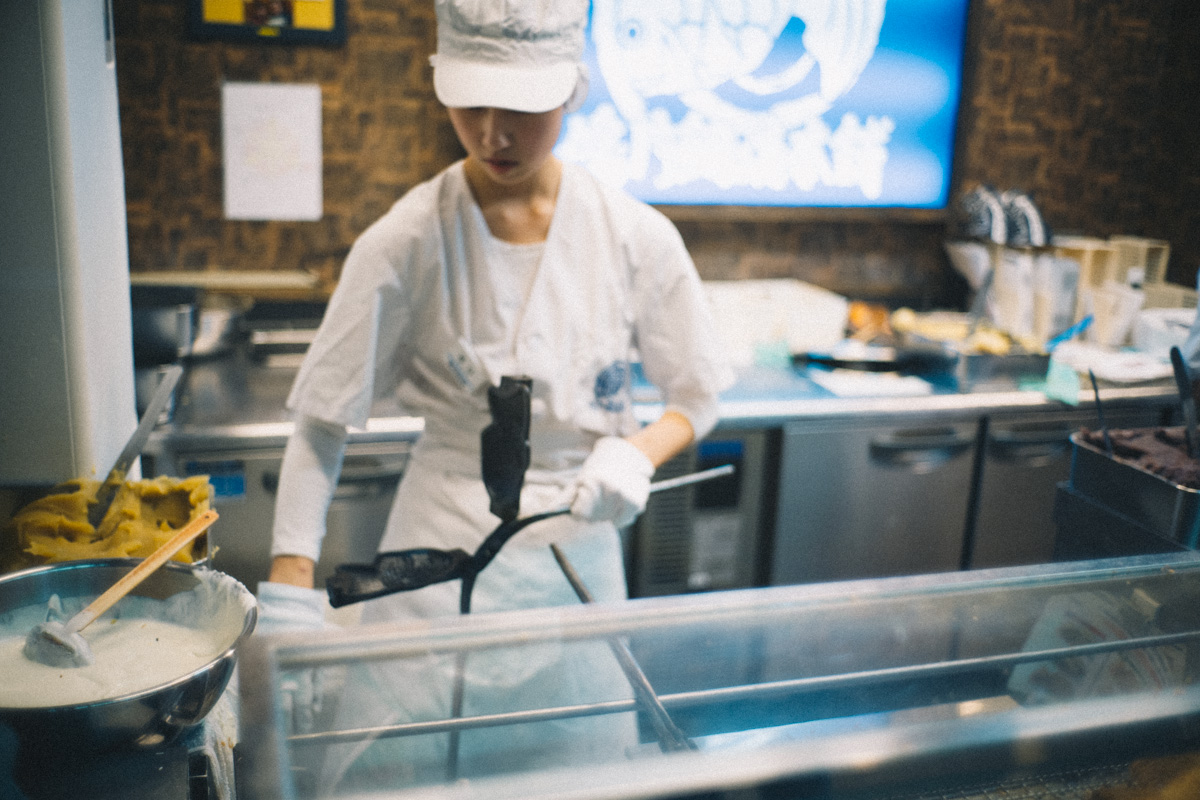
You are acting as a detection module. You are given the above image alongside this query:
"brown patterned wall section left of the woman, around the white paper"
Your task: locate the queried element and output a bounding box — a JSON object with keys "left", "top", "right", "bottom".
{"left": 114, "top": 0, "right": 462, "bottom": 282}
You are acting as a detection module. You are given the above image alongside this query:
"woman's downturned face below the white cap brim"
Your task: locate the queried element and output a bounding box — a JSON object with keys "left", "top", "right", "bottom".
{"left": 449, "top": 108, "right": 564, "bottom": 186}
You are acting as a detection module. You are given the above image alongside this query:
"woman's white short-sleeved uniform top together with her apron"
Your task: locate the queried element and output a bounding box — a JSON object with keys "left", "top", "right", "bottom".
{"left": 275, "top": 163, "right": 731, "bottom": 789}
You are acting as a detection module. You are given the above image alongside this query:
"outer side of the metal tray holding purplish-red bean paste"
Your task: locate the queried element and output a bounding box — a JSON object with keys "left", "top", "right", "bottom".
{"left": 1070, "top": 432, "right": 1200, "bottom": 549}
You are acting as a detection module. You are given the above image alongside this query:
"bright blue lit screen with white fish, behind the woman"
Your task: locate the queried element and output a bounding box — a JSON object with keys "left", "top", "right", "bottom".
{"left": 558, "top": 0, "right": 970, "bottom": 209}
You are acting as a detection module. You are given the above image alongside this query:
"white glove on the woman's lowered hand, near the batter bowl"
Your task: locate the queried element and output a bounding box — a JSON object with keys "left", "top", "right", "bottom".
{"left": 254, "top": 581, "right": 326, "bottom": 733}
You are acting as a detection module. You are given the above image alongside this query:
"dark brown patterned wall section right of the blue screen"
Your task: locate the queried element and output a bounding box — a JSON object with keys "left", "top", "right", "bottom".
{"left": 959, "top": 0, "right": 1200, "bottom": 283}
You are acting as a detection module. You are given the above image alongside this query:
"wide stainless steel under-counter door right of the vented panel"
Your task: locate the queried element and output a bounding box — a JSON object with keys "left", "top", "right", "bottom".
{"left": 770, "top": 420, "right": 978, "bottom": 585}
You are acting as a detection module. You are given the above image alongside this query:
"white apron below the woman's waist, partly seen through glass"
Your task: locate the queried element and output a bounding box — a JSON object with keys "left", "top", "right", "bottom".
{"left": 323, "top": 458, "right": 637, "bottom": 794}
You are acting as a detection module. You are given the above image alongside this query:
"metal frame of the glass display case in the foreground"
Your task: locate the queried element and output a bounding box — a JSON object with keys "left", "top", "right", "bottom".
{"left": 240, "top": 552, "right": 1200, "bottom": 800}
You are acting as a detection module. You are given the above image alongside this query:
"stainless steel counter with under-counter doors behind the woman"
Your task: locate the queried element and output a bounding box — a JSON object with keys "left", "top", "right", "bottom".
{"left": 146, "top": 350, "right": 1175, "bottom": 596}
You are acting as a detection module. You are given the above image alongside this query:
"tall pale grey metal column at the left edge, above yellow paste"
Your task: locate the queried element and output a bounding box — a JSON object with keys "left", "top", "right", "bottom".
{"left": 0, "top": 0, "right": 137, "bottom": 487}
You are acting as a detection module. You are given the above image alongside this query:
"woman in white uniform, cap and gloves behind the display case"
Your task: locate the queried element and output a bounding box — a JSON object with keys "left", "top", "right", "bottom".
{"left": 259, "top": 0, "right": 728, "bottom": 782}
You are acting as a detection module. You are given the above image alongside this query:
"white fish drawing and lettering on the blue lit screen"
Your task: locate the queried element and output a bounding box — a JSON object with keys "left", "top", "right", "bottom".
{"left": 564, "top": 0, "right": 894, "bottom": 197}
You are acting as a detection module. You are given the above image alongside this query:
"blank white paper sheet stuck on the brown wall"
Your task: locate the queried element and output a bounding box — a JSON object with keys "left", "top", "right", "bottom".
{"left": 221, "top": 83, "right": 322, "bottom": 221}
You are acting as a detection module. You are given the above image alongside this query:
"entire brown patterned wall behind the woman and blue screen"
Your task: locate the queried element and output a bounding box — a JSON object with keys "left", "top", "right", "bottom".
{"left": 115, "top": 0, "right": 1200, "bottom": 307}
